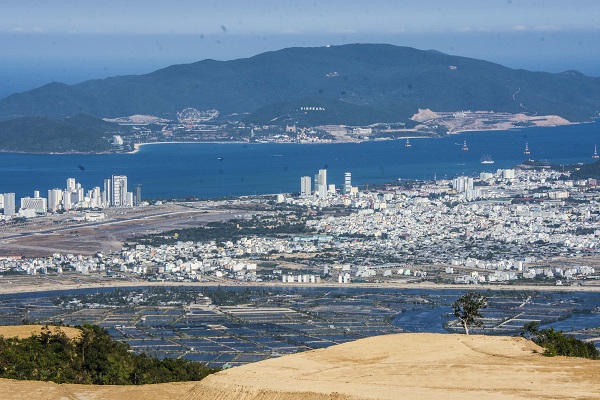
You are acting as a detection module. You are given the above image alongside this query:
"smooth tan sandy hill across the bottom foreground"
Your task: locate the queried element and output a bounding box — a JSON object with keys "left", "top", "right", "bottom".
{"left": 0, "top": 333, "right": 600, "bottom": 400}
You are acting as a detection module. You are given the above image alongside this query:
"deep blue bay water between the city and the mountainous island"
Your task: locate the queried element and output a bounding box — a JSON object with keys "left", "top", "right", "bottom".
{"left": 0, "top": 120, "right": 600, "bottom": 202}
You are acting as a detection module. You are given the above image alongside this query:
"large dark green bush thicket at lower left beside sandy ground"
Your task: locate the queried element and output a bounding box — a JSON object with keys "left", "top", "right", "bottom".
{"left": 0, "top": 325, "right": 216, "bottom": 385}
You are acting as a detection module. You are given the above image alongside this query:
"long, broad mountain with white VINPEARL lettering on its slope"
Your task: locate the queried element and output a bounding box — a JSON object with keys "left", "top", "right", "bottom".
{"left": 0, "top": 44, "right": 600, "bottom": 123}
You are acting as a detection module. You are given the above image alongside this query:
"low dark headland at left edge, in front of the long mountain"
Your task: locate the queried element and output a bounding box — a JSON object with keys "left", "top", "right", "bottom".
{"left": 0, "top": 115, "right": 119, "bottom": 153}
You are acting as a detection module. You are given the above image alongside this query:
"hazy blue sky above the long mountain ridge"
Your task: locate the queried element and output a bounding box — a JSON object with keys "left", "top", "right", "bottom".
{"left": 0, "top": 0, "right": 600, "bottom": 98}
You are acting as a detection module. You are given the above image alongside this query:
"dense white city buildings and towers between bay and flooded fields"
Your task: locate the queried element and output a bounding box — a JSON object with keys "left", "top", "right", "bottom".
{"left": 0, "top": 163, "right": 600, "bottom": 285}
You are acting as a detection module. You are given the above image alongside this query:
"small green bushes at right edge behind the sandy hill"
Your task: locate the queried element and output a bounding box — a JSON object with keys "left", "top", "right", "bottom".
{"left": 521, "top": 322, "right": 600, "bottom": 360}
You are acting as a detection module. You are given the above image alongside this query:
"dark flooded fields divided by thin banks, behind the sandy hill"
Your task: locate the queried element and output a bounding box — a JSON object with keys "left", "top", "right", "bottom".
{"left": 0, "top": 287, "right": 600, "bottom": 367}
